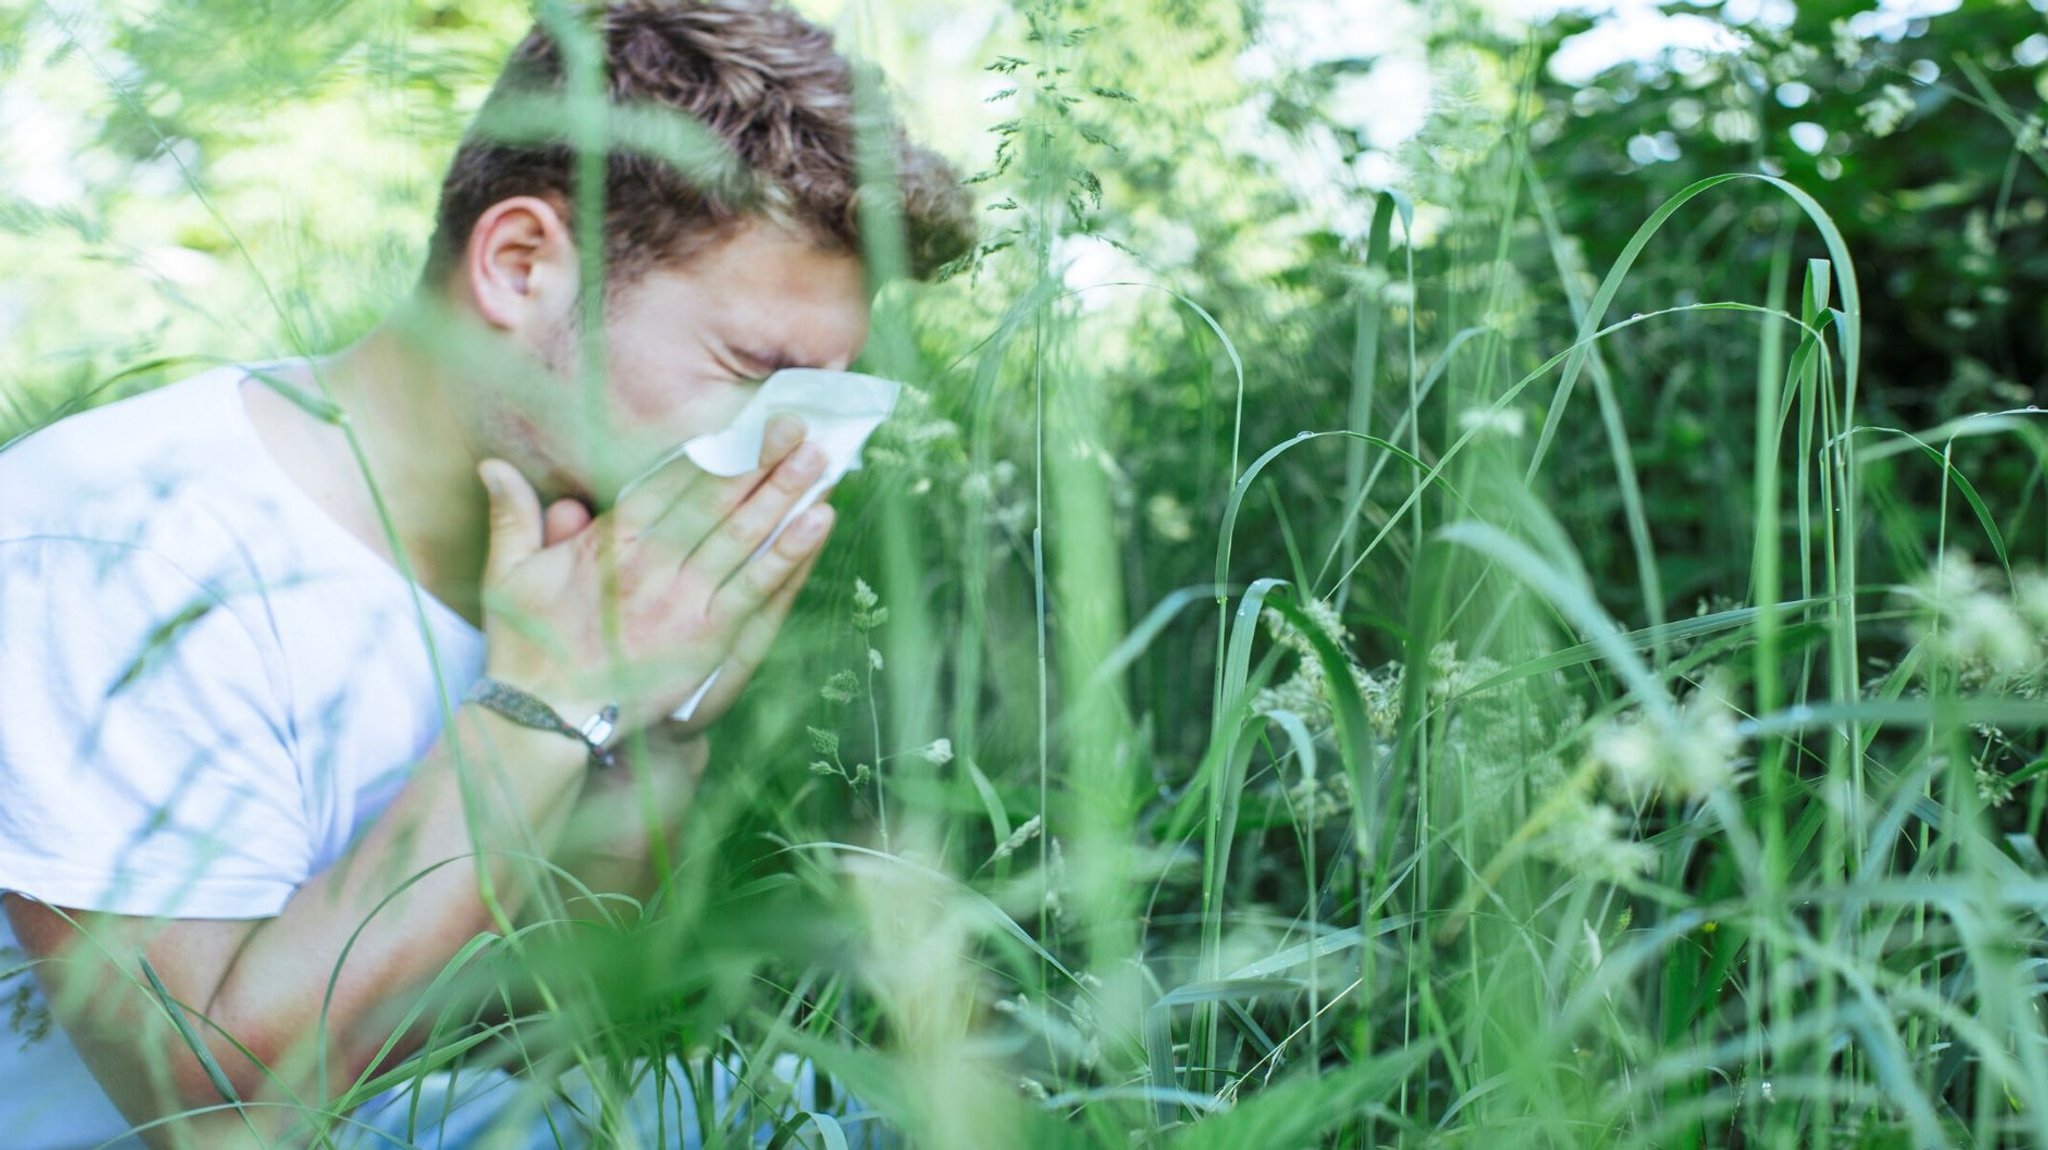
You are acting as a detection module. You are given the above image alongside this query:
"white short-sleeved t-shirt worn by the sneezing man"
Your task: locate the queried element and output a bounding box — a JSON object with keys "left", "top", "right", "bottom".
{"left": 0, "top": 368, "right": 483, "bottom": 1150}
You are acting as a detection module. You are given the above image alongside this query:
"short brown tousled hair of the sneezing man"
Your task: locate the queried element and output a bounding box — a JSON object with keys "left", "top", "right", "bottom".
{"left": 428, "top": 0, "right": 973, "bottom": 289}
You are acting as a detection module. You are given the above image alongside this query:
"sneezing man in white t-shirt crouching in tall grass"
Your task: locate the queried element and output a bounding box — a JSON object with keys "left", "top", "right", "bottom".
{"left": 0, "top": 0, "right": 967, "bottom": 1150}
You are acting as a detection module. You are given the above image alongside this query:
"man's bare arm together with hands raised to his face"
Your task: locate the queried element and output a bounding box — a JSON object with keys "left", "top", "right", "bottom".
{"left": 6, "top": 415, "right": 831, "bottom": 1148}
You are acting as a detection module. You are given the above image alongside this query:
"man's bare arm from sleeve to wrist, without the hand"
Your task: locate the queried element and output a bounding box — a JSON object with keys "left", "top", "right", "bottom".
{"left": 6, "top": 706, "right": 588, "bottom": 1148}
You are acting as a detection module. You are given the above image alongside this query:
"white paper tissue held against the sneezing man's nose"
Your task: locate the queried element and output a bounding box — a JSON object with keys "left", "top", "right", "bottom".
{"left": 621, "top": 368, "right": 903, "bottom": 720}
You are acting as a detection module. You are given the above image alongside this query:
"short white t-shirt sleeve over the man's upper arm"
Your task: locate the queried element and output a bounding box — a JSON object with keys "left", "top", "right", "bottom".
{"left": 0, "top": 538, "right": 313, "bottom": 919}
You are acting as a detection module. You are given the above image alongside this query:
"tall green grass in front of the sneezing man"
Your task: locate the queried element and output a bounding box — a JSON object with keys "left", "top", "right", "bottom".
{"left": 12, "top": 0, "right": 2048, "bottom": 1150}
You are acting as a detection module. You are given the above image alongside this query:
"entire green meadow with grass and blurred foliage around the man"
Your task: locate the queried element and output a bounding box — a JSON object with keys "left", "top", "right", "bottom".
{"left": 0, "top": 0, "right": 2048, "bottom": 1150}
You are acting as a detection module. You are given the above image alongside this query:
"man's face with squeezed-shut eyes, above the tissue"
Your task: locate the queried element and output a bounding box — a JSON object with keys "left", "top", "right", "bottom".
{"left": 505, "top": 223, "right": 868, "bottom": 510}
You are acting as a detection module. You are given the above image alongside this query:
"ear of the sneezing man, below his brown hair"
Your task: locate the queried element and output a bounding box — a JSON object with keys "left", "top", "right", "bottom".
{"left": 463, "top": 196, "right": 582, "bottom": 340}
